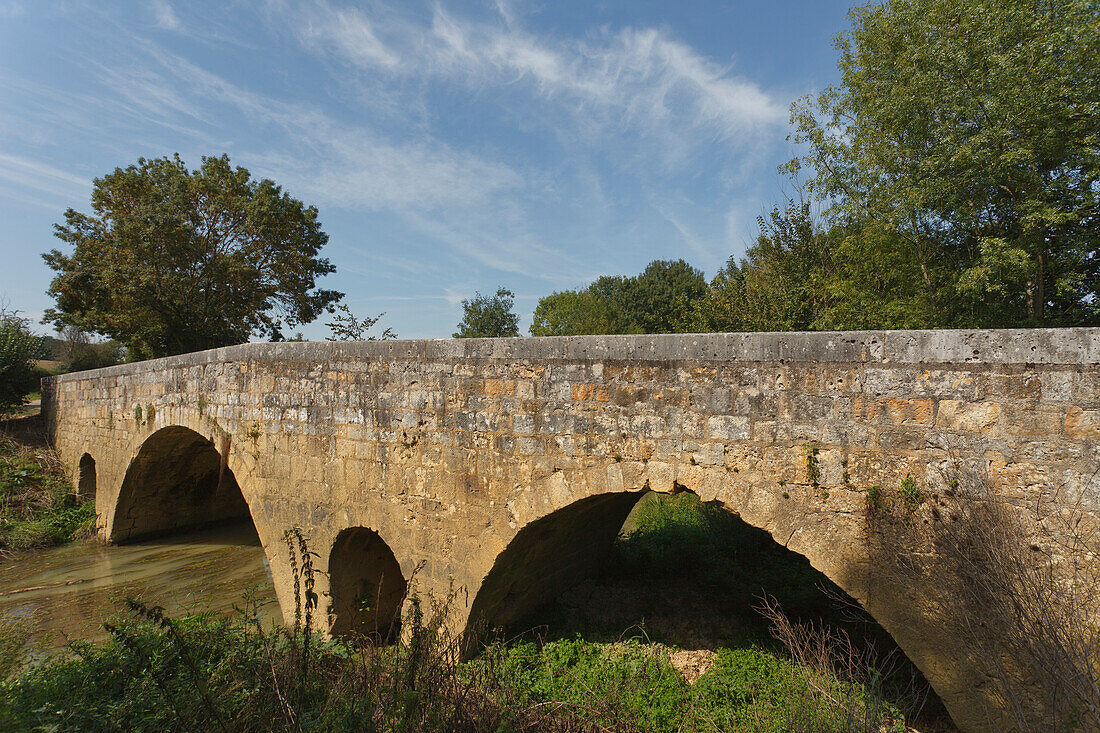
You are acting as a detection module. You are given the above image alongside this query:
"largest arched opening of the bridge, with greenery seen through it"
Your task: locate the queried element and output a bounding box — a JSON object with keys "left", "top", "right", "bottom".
{"left": 466, "top": 491, "right": 950, "bottom": 730}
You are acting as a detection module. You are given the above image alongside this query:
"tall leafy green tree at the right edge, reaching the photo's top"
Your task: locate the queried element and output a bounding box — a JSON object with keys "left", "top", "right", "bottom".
{"left": 788, "top": 0, "right": 1100, "bottom": 327}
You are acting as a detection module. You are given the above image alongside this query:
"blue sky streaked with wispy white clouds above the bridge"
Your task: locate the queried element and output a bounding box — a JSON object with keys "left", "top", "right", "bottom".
{"left": 0, "top": 0, "right": 856, "bottom": 338}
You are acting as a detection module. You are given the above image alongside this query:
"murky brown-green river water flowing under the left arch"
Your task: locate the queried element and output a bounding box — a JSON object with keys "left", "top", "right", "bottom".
{"left": 0, "top": 524, "right": 279, "bottom": 654}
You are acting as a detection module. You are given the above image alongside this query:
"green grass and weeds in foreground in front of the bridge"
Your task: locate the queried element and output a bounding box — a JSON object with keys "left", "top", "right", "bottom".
{"left": 0, "top": 589, "right": 905, "bottom": 733}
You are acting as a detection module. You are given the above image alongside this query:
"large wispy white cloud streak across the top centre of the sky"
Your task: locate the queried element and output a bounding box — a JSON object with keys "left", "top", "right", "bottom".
{"left": 294, "top": 1, "right": 785, "bottom": 147}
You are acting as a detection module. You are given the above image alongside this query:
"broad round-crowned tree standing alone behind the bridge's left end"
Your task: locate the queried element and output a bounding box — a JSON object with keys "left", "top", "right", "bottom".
{"left": 43, "top": 155, "right": 342, "bottom": 359}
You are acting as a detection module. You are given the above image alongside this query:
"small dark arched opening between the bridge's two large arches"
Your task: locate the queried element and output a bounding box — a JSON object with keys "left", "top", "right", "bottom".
{"left": 329, "top": 527, "right": 408, "bottom": 641}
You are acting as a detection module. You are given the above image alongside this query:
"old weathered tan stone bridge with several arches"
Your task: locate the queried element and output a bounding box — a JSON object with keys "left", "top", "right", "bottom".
{"left": 43, "top": 329, "right": 1100, "bottom": 730}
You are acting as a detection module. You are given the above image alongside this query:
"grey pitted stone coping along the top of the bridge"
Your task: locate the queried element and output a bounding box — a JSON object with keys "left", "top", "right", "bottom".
{"left": 47, "top": 328, "right": 1100, "bottom": 383}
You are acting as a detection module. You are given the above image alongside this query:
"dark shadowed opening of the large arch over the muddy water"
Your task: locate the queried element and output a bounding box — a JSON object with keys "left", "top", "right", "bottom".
{"left": 108, "top": 425, "right": 252, "bottom": 544}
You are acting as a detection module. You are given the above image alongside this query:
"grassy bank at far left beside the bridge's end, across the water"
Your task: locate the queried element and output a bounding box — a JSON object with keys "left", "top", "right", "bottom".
{"left": 0, "top": 418, "right": 96, "bottom": 554}
